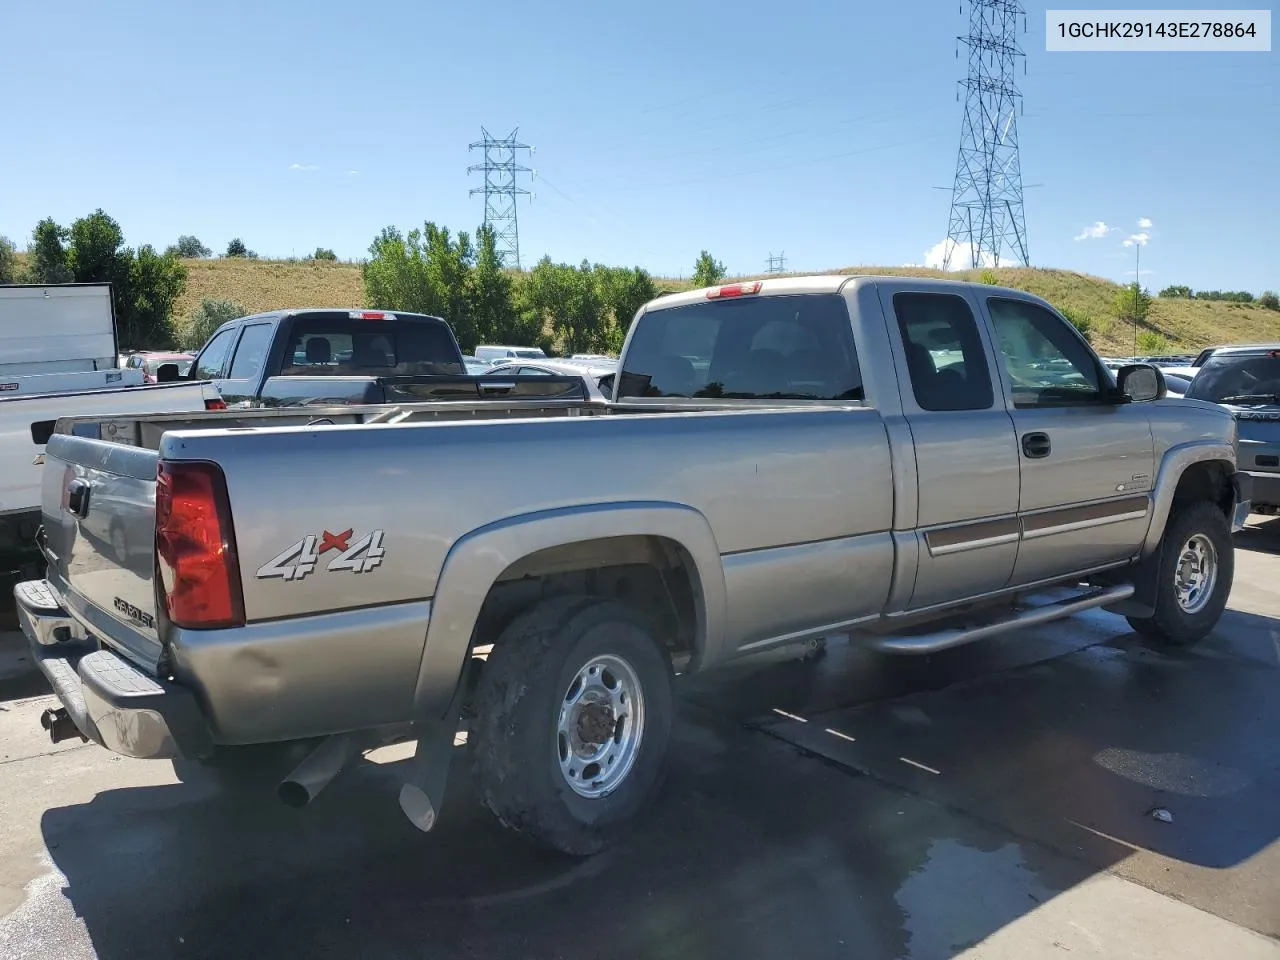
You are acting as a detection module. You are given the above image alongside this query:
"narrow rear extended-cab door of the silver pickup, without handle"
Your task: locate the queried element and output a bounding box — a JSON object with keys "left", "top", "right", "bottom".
{"left": 877, "top": 280, "right": 1018, "bottom": 609}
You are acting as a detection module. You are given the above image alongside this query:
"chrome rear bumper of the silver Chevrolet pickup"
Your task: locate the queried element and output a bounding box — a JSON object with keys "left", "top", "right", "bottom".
{"left": 13, "top": 580, "right": 212, "bottom": 759}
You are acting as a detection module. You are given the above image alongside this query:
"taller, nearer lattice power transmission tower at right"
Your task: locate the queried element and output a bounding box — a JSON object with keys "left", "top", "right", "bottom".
{"left": 942, "top": 0, "right": 1028, "bottom": 270}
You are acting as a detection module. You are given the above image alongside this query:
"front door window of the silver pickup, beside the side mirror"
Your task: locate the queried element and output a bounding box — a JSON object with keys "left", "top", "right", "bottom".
{"left": 987, "top": 297, "right": 1110, "bottom": 407}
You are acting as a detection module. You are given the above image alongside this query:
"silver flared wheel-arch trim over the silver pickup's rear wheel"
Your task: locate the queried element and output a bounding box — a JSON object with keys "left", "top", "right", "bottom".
{"left": 413, "top": 502, "right": 728, "bottom": 718}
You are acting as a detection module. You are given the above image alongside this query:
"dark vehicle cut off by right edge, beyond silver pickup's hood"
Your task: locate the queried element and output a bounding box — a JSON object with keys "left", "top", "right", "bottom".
{"left": 1185, "top": 343, "right": 1280, "bottom": 515}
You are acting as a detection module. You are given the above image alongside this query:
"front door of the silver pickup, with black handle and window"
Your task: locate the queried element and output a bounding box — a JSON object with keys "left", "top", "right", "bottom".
{"left": 983, "top": 294, "right": 1155, "bottom": 585}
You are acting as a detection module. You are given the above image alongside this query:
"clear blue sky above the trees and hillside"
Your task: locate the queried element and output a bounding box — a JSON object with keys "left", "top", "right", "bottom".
{"left": 0, "top": 0, "right": 1280, "bottom": 293}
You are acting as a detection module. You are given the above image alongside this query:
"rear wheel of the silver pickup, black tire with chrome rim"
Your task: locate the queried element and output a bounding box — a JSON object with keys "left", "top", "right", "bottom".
{"left": 468, "top": 598, "right": 672, "bottom": 856}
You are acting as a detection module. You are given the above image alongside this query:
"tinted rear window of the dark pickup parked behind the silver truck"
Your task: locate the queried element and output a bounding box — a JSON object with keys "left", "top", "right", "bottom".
{"left": 280, "top": 315, "right": 466, "bottom": 376}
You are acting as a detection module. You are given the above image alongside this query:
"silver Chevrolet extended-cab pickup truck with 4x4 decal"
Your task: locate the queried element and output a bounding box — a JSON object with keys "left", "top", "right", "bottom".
{"left": 15, "top": 276, "right": 1249, "bottom": 855}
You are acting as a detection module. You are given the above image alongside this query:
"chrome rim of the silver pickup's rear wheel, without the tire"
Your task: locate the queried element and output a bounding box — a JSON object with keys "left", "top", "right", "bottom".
{"left": 556, "top": 654, "right": 644, "bottom": 799}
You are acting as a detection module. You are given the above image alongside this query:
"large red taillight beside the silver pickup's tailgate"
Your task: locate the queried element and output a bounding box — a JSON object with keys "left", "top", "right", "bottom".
{"left": 156, "top": 461, "right": 244, "bottom": 628}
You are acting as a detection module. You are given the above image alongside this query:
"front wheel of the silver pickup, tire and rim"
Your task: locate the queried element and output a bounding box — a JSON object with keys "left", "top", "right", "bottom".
{"left": 1128, "top": 500, "right": 1235, "bottom": 646}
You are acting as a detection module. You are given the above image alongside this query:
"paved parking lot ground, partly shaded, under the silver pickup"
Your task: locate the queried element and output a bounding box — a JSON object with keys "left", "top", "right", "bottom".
{"left": 0, "top": 517, "right": 1280, "bottom": 960}
